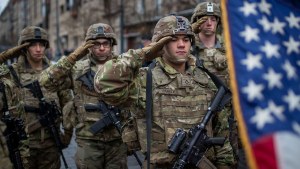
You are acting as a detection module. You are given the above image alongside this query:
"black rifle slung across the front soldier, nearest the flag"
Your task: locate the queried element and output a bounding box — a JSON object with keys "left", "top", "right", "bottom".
{"left": 168, "top": 85, "right": 231, "bottom": 169}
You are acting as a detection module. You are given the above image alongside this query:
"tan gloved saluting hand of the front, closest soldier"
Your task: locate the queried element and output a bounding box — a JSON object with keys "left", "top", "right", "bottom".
{"left": 138, "top": 36, "right": 172, "bottom": 62}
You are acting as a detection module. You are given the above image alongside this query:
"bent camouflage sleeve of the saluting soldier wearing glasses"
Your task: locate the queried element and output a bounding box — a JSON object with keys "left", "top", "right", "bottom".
{"left": 39, "top": 57, "right": 73, "bottom": 92}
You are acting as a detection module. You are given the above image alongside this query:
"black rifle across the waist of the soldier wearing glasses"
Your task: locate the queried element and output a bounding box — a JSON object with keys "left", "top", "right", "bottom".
{"left": 84, "top": 101, "right": 142, "bottom": 166}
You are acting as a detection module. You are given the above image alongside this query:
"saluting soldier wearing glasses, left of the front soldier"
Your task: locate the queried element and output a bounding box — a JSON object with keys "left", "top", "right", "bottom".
{"left": 41, "top": 23, "right": 127, "bottom": 169}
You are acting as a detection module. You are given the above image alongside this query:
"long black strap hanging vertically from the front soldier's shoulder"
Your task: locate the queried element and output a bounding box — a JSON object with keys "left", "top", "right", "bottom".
{"left": 146, "top": 62, "right": 155, "bottom": 169}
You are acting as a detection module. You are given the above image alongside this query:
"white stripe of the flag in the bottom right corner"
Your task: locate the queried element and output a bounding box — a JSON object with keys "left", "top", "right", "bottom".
{"left": 275, "top": 132, "right": 300, "bottom": 169}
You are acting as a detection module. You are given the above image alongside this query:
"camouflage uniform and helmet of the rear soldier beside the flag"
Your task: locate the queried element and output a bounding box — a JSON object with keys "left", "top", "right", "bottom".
{"left": 191, "top": 2, "right": 237, "bottom": 167}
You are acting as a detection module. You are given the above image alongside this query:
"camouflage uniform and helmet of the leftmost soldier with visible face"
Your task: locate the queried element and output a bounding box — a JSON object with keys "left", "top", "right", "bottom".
{"left": 5, "top": 26, "right": 73, "bottom": 169}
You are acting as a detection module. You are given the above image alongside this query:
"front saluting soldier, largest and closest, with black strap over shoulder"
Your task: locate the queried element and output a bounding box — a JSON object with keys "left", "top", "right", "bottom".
{"left": 95, "top": 16, "right": 234, "bottom": 168}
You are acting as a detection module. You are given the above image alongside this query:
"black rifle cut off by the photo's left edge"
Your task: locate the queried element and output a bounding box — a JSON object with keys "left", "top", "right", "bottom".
{"left": 0, "top": 83, "right": 27, "bottom": 169}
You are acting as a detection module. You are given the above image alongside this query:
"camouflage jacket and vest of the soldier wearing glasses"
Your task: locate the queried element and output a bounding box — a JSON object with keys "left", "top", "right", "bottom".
{"left": 41, "top": 54, "right": 121, "bottom": 141}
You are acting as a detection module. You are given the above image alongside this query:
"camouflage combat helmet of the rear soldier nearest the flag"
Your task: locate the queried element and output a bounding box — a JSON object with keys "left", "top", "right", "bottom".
{"left": 191, "top": 2, "right": 221, "bottom": 23}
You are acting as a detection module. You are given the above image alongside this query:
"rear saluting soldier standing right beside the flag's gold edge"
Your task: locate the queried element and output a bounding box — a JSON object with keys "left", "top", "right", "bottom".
{"left": 191, "top": 2, "right": 243, "bottom": 168}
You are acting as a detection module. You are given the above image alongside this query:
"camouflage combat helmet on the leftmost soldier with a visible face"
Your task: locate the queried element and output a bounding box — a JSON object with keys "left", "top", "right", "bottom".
{"left": 18, "top": 26, "right": 49, "bottom": 48}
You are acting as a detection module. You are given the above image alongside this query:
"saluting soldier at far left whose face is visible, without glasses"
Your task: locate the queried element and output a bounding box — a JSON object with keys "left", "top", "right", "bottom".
{"left": 1, "top": 26, "right": 73, "bottom": 169}
